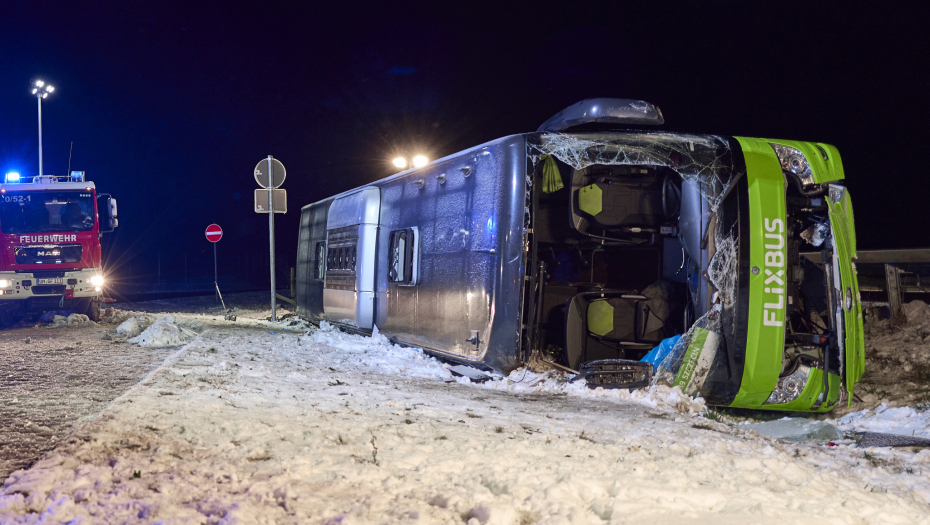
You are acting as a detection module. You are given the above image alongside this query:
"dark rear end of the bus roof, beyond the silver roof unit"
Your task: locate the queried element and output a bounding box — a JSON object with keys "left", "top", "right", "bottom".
{"left": 296, "top": 200, "right": 332, "bottom": 319}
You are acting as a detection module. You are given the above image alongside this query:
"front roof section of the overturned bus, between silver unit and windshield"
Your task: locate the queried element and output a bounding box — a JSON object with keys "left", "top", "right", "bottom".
{"left": 378, "top": 136, "right": 526, "bottom": 370}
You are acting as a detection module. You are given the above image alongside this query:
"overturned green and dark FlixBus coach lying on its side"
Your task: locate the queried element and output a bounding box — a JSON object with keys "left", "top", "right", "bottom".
{"left": 297, "top": 99, "right": 865, "bottom": 412}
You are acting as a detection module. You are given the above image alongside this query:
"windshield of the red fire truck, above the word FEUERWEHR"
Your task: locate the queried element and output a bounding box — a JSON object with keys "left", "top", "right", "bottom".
{"left": 0, "top": 191, "right": 94, "bottom": 233}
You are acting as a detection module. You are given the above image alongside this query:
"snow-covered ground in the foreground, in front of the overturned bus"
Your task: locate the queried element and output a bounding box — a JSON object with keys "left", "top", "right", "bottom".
{"left": 0, "top": 296, "right": 930, "bottom": 525}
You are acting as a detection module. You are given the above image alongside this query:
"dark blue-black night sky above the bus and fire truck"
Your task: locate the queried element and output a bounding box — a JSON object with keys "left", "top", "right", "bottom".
{"left": 0, "top": 0, "right": 930, "bottom": 280}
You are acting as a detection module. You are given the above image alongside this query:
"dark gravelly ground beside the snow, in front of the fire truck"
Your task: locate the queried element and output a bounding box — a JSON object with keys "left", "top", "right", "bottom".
{"left": 0, "top": 292, "right": 286, "bottom": 480}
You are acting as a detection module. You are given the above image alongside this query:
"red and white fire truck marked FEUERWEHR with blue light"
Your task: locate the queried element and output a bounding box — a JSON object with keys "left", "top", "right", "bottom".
{"left": 0, "top": 171, "right": 118, "bottom": 326}
